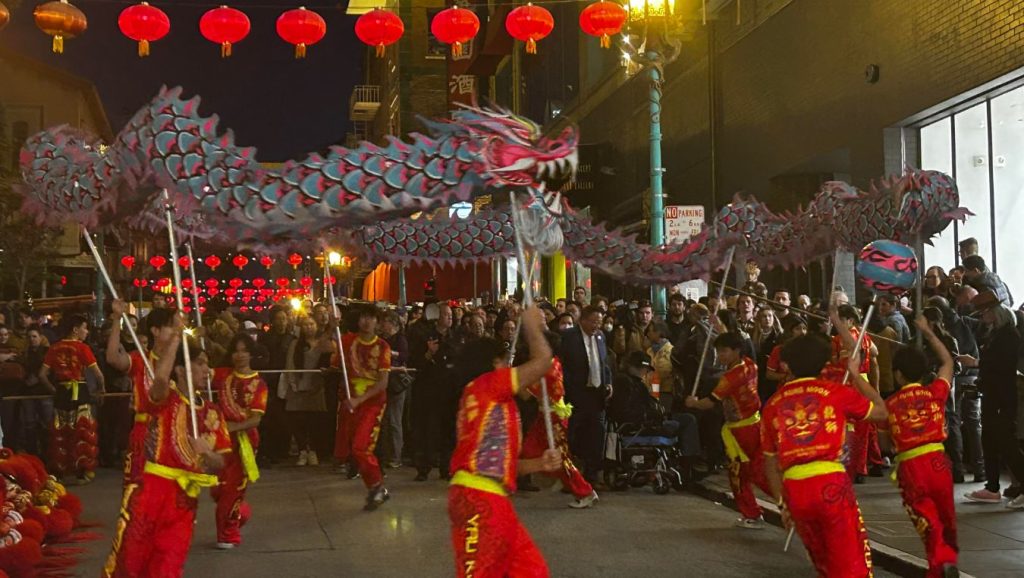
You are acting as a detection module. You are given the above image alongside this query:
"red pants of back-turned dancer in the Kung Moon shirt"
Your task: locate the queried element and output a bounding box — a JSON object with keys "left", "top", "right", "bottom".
{"left": 782, "top": 471, "right": 871, "bottom": 578}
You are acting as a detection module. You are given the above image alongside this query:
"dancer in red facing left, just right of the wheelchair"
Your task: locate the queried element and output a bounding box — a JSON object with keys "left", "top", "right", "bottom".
{"left": 686, "top": 333, "right": 771, "bottom": 530}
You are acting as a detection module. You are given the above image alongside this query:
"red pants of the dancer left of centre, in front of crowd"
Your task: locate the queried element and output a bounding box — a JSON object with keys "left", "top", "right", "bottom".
{"left": 334, "top": 395, "right": 387, "bottom": 490}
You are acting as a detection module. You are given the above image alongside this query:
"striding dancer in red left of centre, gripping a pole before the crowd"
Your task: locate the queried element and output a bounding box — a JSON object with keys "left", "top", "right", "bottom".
{"left": 332, "top": 306, "right": 391, "bottom": 510}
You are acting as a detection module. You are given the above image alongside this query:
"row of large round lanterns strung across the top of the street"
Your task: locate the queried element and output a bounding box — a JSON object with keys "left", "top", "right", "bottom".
{"left": 19, "top": 0, "right": 627, "bottom": 58}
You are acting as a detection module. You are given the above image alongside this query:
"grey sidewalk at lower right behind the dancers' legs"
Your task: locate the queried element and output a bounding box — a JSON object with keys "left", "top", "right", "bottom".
{"left": 699, "top": 473, "right": 1024, "bottom": 578}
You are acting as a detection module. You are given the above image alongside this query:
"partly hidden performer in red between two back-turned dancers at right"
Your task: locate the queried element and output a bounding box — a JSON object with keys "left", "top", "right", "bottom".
{"left": 821, "top": 305, "right": 882, "bottom": 484}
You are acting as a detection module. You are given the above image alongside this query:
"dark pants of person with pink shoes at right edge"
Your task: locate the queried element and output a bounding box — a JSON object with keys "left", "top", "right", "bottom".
{"left": 981, "top": 383, "right": 1024, "bottom": 492}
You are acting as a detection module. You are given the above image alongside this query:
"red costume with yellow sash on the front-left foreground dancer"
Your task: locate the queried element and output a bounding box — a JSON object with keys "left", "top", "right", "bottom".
{"left": 101, "top": 385, "right": 231, "bottom": 578}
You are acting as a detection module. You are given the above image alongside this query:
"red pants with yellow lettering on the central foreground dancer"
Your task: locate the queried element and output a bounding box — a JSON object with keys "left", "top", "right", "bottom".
{"left": 449, "top": 486, "right": 549, "bottom": 578}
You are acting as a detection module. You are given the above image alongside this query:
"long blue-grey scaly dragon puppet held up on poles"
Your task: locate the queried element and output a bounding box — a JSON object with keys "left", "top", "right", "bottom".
{"left": 20, "top": 88, "right": 969, "bottom": 284}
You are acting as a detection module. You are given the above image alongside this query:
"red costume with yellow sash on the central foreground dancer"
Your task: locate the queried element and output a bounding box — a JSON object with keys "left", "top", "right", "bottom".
{"left": 449, "top": 368, "right": 548, "bottom": 578}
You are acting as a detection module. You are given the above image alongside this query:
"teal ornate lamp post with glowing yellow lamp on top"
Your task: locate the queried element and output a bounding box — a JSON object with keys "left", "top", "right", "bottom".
{"left": 623, "top": 0, "right": 682, "bottom": 315}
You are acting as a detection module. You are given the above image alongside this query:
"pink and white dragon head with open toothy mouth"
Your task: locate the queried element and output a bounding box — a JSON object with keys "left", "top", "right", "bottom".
{"left": 419, "top": 107, "right": 579, "bottom": 193}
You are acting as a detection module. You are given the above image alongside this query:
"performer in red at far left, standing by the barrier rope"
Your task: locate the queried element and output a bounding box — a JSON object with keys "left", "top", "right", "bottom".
{"left": 39, "top": 315, "right": 104, "bottom": 484}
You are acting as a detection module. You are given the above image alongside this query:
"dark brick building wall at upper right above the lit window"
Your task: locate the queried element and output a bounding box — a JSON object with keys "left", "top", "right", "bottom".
{"left": 578, "top": 0, "right": 1024, "bottom": 218}
